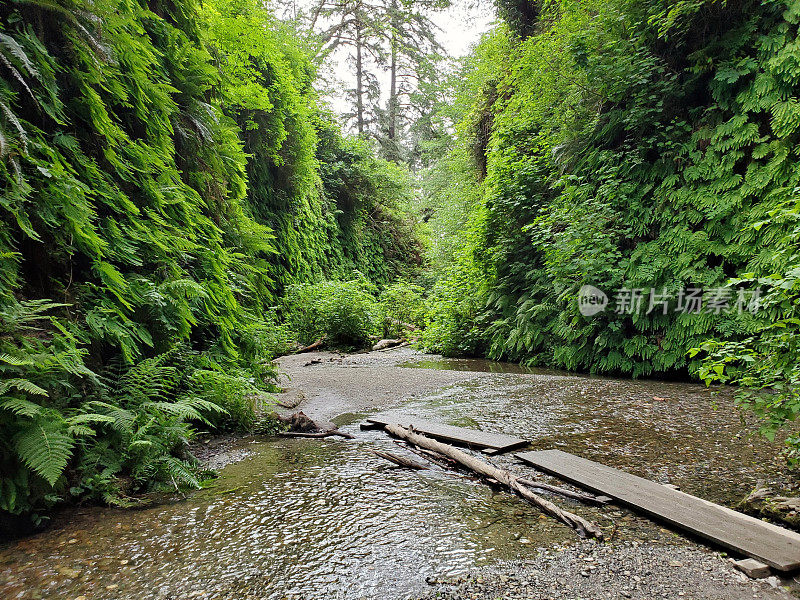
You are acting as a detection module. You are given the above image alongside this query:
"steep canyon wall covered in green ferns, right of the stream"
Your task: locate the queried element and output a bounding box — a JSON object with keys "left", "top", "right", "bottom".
{"left": 425, "top": 0, "right": 800, "bottom": 375}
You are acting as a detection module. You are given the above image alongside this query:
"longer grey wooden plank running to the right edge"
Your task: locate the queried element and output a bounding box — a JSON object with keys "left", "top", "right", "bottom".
{"left": 516, "top": 450, "right": 800, "bottom": 571}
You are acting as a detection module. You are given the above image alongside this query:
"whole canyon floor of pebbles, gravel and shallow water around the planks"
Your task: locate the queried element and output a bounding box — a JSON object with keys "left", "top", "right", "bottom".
{"left": 0, "top": 348, "right": 794, "bottom": 600}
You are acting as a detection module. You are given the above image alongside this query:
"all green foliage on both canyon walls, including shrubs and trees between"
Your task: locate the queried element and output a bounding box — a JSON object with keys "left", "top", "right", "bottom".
{"left": 0, "top": 0, "right": 800, "bottom": 526}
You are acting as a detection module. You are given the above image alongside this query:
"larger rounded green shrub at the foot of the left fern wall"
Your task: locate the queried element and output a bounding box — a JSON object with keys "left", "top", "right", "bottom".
{"left": 284, "top": 277, "right": 380, "bottom": 347}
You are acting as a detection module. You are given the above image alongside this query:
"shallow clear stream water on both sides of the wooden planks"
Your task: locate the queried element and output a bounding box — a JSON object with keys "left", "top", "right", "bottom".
{"left": 0, "top": 356, "right": 785, "bottom": 600}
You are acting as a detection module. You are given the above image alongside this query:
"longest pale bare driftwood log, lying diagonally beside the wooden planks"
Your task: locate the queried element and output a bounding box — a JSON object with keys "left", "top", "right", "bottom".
{"left": 385, "top": 424, "right": 603, "bottom": 540}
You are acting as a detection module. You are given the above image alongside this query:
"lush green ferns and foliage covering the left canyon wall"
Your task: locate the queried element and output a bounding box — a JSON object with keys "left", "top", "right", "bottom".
{"left": 0, "top": 0, "right": 420, "bottom": 520}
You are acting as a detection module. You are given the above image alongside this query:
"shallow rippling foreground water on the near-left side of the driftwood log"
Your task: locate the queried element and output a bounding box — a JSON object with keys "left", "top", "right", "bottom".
{"left": 0, "top": 432, "right": 572, "bottom": 598}
